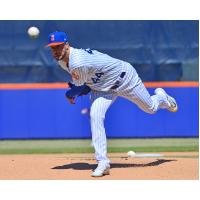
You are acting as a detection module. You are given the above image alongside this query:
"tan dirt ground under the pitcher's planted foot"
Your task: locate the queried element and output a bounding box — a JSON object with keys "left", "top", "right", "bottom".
{"left": 0, "top": 152, "right": 199, "bottom": 180}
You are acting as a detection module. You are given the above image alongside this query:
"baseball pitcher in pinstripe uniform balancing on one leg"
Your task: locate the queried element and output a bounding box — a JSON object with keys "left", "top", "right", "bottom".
{"left": 48, "top": 32, "right": 178, "bottom": 177}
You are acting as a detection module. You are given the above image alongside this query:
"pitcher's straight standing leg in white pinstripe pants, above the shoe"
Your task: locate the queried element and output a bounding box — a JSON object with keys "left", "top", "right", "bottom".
{"left": 90, "top": 93, "right": 116, "bottom": 163}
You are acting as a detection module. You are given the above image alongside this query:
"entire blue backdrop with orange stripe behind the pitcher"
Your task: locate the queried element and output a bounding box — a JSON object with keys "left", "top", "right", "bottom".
{"left": 0, "top": 20, "right": 199, "bottom": 139}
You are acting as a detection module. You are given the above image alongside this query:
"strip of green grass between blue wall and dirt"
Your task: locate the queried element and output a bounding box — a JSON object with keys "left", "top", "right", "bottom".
{"left": 0, "top": 138, "right": 199, "bottom": 154}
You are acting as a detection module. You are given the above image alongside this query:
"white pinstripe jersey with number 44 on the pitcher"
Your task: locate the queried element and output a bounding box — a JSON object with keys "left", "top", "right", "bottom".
{"left": 58, "top": 47, "right": 138, "bottom": 91}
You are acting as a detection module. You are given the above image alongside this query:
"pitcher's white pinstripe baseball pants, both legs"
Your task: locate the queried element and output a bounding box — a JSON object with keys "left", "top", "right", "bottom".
{"left": 90, "top": 65, "right": 169, "bottom": 163}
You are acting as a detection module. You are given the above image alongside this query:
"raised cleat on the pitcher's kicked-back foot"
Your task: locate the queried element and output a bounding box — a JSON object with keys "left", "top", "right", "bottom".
{"left": 155, "top": 88, "right": 178, "bottom": 112}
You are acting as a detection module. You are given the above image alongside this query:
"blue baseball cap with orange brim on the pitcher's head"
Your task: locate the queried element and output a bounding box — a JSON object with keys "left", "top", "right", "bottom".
{"left": 47, "top": 31, "right": 68, "bottom": 47}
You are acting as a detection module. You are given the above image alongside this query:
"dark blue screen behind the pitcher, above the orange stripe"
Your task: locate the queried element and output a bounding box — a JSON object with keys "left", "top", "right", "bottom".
{"left": 0, "top": 20, "right": 199, "bottom": 83}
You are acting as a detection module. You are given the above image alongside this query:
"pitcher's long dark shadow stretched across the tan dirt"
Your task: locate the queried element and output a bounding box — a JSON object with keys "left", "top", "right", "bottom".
{"left": 52, "top": 159, "right": 176, "bottom": 170}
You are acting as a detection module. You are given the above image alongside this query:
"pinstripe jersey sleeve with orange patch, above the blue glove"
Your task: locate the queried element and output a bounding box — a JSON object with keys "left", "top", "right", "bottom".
{"left": 71, "top": 67, "right": 88, "bottom": 86}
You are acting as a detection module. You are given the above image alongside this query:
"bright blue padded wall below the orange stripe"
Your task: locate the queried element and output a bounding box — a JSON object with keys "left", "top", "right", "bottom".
{"left": 0, "top": 87, "right": 199, "bottom": 139}
